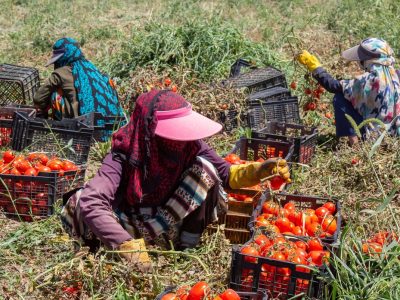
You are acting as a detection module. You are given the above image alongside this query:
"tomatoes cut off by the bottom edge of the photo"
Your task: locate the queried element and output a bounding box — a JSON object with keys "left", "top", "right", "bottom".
{"left": 161, "top": 281, "right": 240, "bottom": 300}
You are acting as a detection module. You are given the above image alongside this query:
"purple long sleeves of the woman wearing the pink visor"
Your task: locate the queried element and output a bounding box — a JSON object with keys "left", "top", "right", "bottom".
{"left": 80, "top": 141, "right": 231, "bottom": 249}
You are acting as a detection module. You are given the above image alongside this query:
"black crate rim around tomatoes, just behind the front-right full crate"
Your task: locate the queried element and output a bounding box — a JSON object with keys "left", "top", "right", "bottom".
{"left": 249, "top": 193, "right": 342, "bottom": 245}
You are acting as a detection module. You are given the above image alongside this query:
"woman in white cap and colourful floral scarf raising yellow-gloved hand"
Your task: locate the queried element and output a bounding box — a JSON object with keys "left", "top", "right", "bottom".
{"left": 298, "top": 38, "right": 400, "bottom": 145}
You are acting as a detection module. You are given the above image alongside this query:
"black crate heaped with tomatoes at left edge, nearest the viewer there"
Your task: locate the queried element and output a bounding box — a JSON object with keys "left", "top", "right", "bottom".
{"left": 0, "top": 151, "right": 85, "bottom": 221}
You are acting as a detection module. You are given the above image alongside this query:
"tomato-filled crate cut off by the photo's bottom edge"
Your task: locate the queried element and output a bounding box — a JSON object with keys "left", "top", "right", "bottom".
{"left": 156, "top": 281, "right": 268, "bottom": 300}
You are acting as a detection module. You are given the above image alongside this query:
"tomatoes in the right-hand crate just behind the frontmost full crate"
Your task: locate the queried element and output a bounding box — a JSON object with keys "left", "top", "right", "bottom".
{"left": 255, "top": 200, "right": 337, "bottom": 238}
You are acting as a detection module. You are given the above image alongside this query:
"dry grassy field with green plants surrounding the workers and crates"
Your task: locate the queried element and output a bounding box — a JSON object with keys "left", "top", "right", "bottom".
{"left": 0, "top": 0, "right": 400, "bottom": 300}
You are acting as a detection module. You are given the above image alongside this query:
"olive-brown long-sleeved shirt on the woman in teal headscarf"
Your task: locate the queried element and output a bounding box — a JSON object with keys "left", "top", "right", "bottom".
{"left": 33, "top": 66, "right": 79, "bottom": 118}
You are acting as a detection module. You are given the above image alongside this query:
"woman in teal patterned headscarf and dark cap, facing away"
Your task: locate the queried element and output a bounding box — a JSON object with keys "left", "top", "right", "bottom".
{"left": 34, "top": 38, "right": 124, "bottom": 126}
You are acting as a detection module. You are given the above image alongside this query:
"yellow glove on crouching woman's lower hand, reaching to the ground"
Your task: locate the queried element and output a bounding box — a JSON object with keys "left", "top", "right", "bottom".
{"left": 118, "top": 239, "right": 152, "bottom": 272}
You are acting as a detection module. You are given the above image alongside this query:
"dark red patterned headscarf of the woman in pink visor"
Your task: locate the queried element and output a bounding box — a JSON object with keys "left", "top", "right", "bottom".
{"left": 112, "top": 90, "right": 199, "bottom": 206}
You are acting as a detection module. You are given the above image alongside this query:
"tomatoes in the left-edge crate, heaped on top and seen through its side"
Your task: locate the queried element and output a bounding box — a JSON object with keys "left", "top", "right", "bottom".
{"left": 0, "top": 151, "right": 78, "bottom": 221}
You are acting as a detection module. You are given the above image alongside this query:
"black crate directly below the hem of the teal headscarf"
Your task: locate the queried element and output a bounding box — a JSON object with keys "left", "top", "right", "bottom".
{"left": 76, "top": 112, "right": 127, "bottom": 142}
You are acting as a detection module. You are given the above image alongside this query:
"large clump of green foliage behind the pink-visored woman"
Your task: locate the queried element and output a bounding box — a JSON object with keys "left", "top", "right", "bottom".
{"left": 105, "top": 19, "right": 279, "bottom": 80}
